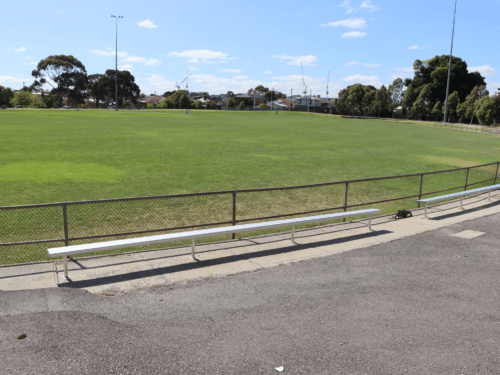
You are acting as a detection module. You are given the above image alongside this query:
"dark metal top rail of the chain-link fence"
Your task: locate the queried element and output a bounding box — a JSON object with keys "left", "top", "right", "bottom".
{"left": 0, "top": 161, "right": 500, "bottom": 210}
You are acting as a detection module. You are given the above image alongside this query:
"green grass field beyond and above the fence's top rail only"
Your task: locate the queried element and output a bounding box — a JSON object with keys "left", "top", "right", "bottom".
{"left": 0, "top": 110, "right": 500, "bottom": 206}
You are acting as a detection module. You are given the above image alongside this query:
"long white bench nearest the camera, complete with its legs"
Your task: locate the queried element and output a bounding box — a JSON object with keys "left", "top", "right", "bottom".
{"left": 47, "top": 208, "right": 382, "bottom": 278}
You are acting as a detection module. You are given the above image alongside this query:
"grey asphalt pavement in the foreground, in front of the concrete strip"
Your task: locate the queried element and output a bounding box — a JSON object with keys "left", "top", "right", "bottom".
{"left": 0, "top": 209, "right": 500, "bottom": 375}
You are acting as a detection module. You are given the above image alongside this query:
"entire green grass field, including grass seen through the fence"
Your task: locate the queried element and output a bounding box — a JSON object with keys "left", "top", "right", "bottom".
{"left": 0, "top": 110, "right": 500, "bottom": 264}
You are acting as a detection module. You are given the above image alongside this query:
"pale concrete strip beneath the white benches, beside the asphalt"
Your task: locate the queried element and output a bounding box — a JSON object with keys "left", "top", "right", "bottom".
{"left": 0, "top": 191, "right": 500, "bottom": 294}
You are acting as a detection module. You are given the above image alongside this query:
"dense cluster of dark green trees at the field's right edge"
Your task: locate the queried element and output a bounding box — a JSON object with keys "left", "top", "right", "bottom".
{"left": 334, "top": 55, "right": 500, "bottom": 125}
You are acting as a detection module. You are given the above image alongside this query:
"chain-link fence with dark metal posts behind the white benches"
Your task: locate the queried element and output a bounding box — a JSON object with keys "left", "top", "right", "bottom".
{"left": 0, "top": 162, "right": 500, "bottom": 265}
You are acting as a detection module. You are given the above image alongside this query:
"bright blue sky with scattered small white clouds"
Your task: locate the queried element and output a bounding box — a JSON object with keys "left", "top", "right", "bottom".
{"left": 0, "top": 0, "right": 500, "bottom": 97}
